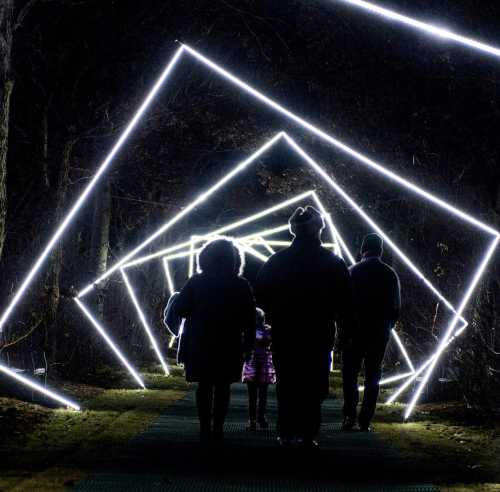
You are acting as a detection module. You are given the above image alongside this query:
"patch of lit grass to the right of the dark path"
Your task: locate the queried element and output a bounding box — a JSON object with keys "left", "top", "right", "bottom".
{"left": 374, "top": 402, "right": 500, "bottom": 492}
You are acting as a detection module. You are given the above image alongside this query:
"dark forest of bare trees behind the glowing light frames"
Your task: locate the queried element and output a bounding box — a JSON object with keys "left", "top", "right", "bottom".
{"left": 0, "top": 0, "right": 500, "bottom": 411}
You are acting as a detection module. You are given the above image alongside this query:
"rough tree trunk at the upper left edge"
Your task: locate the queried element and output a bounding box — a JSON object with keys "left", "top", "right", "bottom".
{"left": 0, "top": 0, "right": 14, "bottom": 258}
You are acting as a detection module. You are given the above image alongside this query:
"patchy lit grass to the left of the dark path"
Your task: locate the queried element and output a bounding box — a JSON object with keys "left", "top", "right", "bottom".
{"left": 0, "top": 369, "right": 188, "bottom": 492}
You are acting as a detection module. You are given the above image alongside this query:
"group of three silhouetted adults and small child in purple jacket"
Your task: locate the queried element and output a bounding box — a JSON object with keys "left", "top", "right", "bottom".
{"left": 166, "top": 206, "right": 400, "bottom": 448}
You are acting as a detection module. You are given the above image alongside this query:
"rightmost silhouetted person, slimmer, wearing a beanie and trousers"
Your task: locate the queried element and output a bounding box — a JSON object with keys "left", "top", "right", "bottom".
{"left": 340, "top": 234, "right": 401, "bottom": 431}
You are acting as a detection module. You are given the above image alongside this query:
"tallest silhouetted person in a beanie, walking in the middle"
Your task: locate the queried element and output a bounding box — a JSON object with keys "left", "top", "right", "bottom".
{"left": 255, "top": 206, "right": 353, "bottom": 449}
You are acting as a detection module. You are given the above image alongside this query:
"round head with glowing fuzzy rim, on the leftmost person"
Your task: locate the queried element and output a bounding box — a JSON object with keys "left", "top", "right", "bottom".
{"left": 198, "top": 237, "right": 245, "bottom": 275}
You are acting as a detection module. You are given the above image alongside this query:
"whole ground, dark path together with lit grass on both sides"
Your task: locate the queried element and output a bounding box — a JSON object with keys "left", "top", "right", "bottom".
{"left": 0, "top": 368, "right": 500, "bottom": 492}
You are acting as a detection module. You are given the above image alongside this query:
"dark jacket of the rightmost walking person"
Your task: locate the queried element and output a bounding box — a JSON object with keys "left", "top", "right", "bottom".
{"left": 350, "top": 256, "right": 401, "bottom": 343}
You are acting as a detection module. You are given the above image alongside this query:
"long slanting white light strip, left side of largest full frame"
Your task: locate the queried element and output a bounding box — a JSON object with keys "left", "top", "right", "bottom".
{"left": 0, "top": 47, "right": 184, "bottom": 332}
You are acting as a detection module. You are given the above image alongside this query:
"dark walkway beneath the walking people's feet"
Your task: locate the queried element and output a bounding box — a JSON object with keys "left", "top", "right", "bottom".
{"left": 76, "top": 385, "right": 435, "bottom": 492}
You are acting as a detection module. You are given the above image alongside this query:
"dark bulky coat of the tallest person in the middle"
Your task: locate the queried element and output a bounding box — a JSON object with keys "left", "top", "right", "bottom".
{"left": 256, "top": 237, "right": 352, "bottom": 360}
